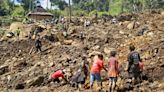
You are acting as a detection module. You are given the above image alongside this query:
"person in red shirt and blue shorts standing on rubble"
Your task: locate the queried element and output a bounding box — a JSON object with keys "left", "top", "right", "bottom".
{"left": 90, "top": 54, "right": 107, "bottom": 88}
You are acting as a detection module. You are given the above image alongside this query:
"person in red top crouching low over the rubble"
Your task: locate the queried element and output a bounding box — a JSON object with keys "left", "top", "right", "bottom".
{"left": 50, "top": 69, "right": 67, "bottom": 83}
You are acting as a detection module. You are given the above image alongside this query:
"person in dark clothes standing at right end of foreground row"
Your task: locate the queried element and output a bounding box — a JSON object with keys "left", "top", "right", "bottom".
{"left": 127, "top": 45, "right": 141, "bottom": 84}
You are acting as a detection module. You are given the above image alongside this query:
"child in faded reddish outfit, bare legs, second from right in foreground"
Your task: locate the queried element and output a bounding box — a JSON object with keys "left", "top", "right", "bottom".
{"left": 108, "top": 51, "right": 119, "bottom": 92}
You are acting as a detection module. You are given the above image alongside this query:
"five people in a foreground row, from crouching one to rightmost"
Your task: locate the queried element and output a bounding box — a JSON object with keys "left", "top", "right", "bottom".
{"left": 48, "top": 45, "right": 143, "bottom": 92}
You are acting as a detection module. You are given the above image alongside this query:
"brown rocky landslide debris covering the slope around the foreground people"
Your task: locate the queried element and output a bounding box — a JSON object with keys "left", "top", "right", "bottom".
{"left": 0, "top": 11, "right": 164, "bottom": 92}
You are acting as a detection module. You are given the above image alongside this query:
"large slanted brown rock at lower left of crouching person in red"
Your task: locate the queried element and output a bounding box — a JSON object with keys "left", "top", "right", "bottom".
{"left": 25, "top": 76, "right": 44, "bottom": 87}
